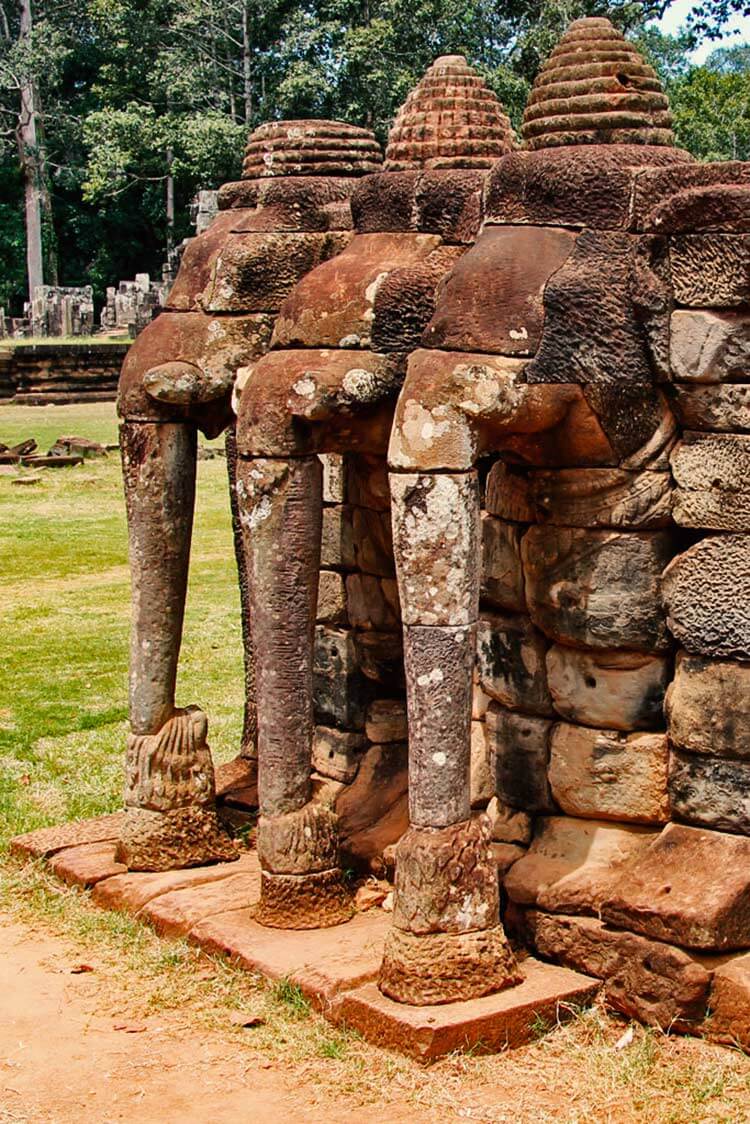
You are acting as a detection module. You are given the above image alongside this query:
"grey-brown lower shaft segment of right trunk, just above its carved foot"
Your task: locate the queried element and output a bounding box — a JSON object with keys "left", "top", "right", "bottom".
{"left": 404, "top": 625, "right": 476, "bottom": 827}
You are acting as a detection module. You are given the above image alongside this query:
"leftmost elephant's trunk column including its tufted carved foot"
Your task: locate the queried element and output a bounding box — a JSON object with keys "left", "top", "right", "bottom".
{"left": 117, "top": 422, "right": 237, "bottom": 870}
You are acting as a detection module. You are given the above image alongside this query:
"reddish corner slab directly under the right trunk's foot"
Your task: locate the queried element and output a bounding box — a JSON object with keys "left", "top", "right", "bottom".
{"left": 335, "top": 957, "right": 599, "bottom": 1061}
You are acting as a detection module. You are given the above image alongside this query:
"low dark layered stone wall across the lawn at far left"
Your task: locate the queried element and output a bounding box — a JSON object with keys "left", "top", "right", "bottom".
{"left": 12, "top": 343, "right": 128, "bottom": 406}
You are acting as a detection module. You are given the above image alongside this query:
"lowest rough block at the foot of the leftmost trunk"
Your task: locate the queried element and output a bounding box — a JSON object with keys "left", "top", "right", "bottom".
{"left": 115, "top": 805, "right": 240, "bottom": 870}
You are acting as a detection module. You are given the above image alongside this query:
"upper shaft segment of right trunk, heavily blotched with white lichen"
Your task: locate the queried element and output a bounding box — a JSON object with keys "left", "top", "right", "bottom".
{"left": 390, "top": 472, "right": 479, "bottom": 625}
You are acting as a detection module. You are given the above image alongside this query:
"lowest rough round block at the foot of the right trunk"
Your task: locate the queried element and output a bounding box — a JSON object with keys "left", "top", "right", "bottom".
{"left": 378, "top": 925, "right": 523, "bottom": 1007}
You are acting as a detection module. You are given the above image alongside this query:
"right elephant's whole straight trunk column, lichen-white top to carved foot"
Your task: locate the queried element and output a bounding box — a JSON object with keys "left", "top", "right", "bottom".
{"left": 379, "top": 471, "right": 521, "bottom": 1005}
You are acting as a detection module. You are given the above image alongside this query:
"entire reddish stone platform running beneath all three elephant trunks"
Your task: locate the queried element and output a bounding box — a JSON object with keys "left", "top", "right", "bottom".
{"left": 11, "top": 816, "right": 599, "bottom": 1061}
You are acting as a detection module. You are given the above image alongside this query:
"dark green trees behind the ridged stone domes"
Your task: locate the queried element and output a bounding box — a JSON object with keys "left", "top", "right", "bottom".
{"left": 0, "top": 0, "right": 750, "bottom": 311}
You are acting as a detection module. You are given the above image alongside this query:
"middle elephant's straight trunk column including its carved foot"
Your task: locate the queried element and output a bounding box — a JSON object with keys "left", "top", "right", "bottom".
{"left": 237, "top": 456, "right": 352, "bottom": 928}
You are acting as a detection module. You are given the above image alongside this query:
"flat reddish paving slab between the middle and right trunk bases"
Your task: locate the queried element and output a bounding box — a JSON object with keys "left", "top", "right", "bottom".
{"left": 188, "top": 908, "right": 390, "bottom": 1013}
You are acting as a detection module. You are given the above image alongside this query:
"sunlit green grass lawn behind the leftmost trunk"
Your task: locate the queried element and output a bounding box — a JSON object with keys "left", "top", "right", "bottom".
{"left": 0, "top": 402, "right": 242, "bottom": 849}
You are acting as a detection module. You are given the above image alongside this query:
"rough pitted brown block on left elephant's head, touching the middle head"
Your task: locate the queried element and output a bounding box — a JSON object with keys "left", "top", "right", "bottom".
{"left": 200, "top": 232, "right": 351, "bottom": 312}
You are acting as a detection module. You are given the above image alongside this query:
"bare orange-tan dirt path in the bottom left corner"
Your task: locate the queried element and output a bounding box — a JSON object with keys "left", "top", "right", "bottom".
{"left": 0, "top": 921, "right": 428, "bottom": 1124}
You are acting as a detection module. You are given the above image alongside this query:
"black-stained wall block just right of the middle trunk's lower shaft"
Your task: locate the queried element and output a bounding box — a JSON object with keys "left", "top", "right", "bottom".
{"left": 313, "top": 626, "right": 372, "bottom": 729}
